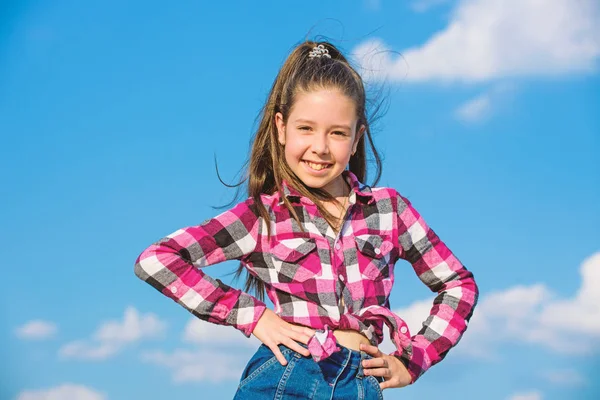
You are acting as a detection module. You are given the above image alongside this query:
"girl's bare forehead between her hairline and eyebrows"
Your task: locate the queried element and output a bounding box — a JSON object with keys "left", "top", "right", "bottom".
{"left": 289, "top": 89, "right": 357, "bottom": 122}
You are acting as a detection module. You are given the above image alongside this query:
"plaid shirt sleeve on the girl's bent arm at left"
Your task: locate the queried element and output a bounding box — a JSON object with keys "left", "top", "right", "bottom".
{"left": 134, "top": 199, "right": 266, "bottom": 337}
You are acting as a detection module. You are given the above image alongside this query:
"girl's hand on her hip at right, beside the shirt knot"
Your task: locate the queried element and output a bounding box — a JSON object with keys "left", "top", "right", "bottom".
{"left": 360, "top": 343, "right": 412, "bottom": 390}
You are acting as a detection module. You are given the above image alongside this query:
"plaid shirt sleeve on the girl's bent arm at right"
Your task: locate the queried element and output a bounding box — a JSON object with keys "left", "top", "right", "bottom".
{"left": 393, "top": 194, "right": 479, "bottom": 383}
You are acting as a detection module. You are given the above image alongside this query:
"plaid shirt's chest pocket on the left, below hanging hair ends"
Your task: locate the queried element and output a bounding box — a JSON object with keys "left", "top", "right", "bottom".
{"left": 271, "top": 238, "right": 321, "bottom": 284}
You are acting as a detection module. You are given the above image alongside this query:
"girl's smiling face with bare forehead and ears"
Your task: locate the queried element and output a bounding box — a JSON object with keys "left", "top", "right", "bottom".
{"left": 275, "top": 89, "right": 365, "bottom": 197}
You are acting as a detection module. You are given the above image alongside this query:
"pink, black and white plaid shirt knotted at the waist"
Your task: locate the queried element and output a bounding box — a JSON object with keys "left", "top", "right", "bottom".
{"left": 135, "top": 171, "right": 478, "bottom": 382}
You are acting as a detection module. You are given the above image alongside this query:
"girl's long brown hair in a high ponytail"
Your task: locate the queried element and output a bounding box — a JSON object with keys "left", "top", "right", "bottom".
{"left": 223, "top": 41, "right": 381, "bottom": 300}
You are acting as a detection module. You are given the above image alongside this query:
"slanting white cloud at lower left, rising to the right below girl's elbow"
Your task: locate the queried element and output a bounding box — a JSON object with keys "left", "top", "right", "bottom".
{"left": 59, "top": 307, "right": 165, "bottom": 361}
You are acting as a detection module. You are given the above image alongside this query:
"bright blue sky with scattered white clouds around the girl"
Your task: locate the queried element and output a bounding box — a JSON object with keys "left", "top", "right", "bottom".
{"left": 0, "top": 0, "right": 600, "bottom": 400}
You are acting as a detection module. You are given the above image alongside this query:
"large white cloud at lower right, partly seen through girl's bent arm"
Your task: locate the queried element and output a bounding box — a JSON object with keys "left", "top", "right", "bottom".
{"left": 380, "top": 252, "right": 600, "bottom": 358}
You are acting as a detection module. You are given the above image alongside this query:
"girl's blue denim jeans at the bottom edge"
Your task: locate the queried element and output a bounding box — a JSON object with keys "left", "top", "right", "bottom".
{"left": 234, "top": 344, "right": 383, "bottom": 400}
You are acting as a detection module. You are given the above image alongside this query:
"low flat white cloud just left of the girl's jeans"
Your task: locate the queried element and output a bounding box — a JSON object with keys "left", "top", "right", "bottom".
{"left": 142, "top": 349, "right": 246, "bottom": 383}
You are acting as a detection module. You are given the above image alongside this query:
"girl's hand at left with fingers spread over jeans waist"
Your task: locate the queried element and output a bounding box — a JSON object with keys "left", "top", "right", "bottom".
{"left": 252, "top": 308, "right": 315, "bottom": 365}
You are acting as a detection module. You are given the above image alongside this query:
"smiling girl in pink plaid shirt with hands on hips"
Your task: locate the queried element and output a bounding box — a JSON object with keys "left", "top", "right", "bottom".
{"left": 135, "top": 42, "right": 478, "bottom": 400}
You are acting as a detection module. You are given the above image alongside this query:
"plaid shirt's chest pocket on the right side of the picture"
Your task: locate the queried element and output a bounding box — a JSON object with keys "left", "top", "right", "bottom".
{"left": 354, "top": 234, "right": 394, "bottom": 280}
